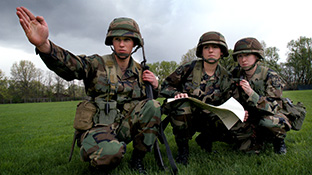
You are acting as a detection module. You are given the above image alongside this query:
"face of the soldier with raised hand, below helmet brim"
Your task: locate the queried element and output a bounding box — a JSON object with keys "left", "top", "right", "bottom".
{"left": 113, "top": 37, "right": 134, "bottom": 57}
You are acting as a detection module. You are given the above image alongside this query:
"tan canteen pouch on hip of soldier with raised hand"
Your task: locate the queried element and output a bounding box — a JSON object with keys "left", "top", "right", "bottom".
{"left": 74, "top": 100, "right": 97, "bottom": 130}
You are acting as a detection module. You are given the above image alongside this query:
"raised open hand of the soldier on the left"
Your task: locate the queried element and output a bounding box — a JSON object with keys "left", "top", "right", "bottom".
{"left": 16, "top": 7, "right": 51, "bottom": 53}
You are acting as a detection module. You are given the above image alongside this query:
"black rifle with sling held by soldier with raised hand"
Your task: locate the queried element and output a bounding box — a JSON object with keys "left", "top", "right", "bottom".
{"left": 141, "top": 46, "right": 178, "bottom": 174}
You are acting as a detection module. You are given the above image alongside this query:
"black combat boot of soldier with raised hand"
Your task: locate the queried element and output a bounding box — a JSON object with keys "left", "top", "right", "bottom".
{"left": 130, "top": 149, "right": 147, "bottom": 174}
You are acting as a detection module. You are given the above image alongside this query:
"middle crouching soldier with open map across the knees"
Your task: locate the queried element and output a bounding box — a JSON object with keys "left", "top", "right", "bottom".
{"left": 160, "top": 31, "right": 236, "bottom": 165}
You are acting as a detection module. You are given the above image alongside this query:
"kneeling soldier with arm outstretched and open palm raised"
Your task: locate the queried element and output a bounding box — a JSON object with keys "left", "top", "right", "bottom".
{"left": 16, "top": 7, "right": 161, "bottom": 174}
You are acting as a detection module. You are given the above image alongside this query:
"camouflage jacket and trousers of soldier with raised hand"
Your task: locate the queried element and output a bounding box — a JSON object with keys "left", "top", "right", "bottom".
{"left": 37, "top": 42, "right": 161, "bottom": 168}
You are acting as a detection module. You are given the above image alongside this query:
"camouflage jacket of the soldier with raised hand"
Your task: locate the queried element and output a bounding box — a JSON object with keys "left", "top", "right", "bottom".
{"left": 37, "top": 42, "right": 157, "bottom": 111}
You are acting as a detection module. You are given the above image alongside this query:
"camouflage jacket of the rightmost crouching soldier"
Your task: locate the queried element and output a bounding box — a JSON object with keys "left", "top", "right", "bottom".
{"left": 233, "top": 63, "right": 284, "bottom": 114}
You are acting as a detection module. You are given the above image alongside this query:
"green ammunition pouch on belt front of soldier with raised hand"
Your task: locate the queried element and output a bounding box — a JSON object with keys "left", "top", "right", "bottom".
{"left": 93, "top": 98, "right": 123, "bottom": 126}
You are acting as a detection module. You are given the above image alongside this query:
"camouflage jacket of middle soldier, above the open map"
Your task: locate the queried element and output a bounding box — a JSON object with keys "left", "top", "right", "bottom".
{"left": 160, "top": 60, "right": 231, "bottom": 105}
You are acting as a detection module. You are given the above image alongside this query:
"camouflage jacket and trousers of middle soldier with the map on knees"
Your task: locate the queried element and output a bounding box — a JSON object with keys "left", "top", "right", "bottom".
{"left": 160, "top": 60, "right": 231, "bottom": 142}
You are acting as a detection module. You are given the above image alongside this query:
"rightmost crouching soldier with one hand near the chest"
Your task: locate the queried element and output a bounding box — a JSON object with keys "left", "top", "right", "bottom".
{"left": 232, "top": 37, "right": 291, "bottom": 154}
